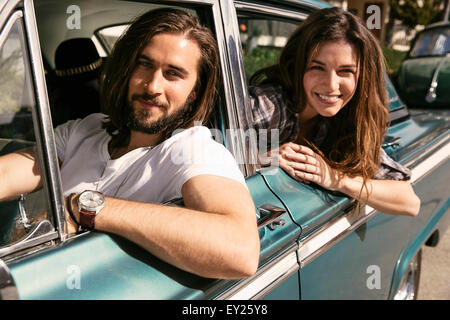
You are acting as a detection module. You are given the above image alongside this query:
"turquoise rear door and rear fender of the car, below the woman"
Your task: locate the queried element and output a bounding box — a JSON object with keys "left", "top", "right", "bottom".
{"left": 262, "top": 80, "right": 450, "bottom": 299}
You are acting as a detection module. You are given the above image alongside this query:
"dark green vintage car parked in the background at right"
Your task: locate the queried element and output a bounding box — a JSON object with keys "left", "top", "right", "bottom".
{"left": 396, "top": 22, "right": 450, "bottom": 108}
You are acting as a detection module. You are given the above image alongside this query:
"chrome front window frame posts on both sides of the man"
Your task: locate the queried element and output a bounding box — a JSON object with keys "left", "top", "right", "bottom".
{"left": 28, "top": 0, "right": 253, "bottom": 242}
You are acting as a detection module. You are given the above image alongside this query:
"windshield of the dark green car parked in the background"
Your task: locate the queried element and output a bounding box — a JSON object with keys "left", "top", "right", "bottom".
{"left": 409, "top": 27, "right": 450, "bottom": 57}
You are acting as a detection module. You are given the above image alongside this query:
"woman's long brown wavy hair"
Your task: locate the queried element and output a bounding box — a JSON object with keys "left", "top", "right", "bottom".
{"left": 250, "top": 8, "right": 388, "bottom": 202}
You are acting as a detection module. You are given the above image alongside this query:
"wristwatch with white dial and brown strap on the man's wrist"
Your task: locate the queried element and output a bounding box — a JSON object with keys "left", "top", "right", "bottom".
{"left": 78, "top": 190, "right": 105, "bottom": 230}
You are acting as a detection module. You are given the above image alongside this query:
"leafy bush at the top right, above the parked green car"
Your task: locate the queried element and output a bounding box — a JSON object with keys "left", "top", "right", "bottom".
{"left": 391, "top": 0, "right": 444, "bottom": 28}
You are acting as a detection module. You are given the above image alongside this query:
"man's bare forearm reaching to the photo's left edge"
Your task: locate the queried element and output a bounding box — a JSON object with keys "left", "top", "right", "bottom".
{"left": 0, "top": 147, "right": 41, "bottom": 201}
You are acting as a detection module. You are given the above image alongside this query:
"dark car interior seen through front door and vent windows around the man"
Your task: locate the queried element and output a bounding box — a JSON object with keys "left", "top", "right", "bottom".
{"left": 0, "top": 0, "right": 229, "bottom": 249}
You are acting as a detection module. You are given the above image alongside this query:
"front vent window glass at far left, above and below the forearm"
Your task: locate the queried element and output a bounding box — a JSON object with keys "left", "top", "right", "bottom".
{"left": 0, "top": 12, "right": 51, "bottom": 252}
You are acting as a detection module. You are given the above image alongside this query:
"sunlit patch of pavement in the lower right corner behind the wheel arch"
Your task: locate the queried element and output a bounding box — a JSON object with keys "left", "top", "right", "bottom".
{"left": 417, "top": 229, "right": 450, "bottom": 300}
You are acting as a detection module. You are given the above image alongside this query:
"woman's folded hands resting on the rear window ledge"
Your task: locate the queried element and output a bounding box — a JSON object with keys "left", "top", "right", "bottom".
{"left": 271, "top": 142, "right": 343, "bottom": 191}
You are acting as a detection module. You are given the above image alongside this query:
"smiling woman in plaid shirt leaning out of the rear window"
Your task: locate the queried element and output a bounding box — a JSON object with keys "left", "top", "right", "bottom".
{"left": 250, "top": 8, "right": 420, "bottom": 216}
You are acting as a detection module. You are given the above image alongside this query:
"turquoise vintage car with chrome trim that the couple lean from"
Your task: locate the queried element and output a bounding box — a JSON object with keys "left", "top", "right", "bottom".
{"left": 0, "top": 0, "right": 450, "bottom": 300}
